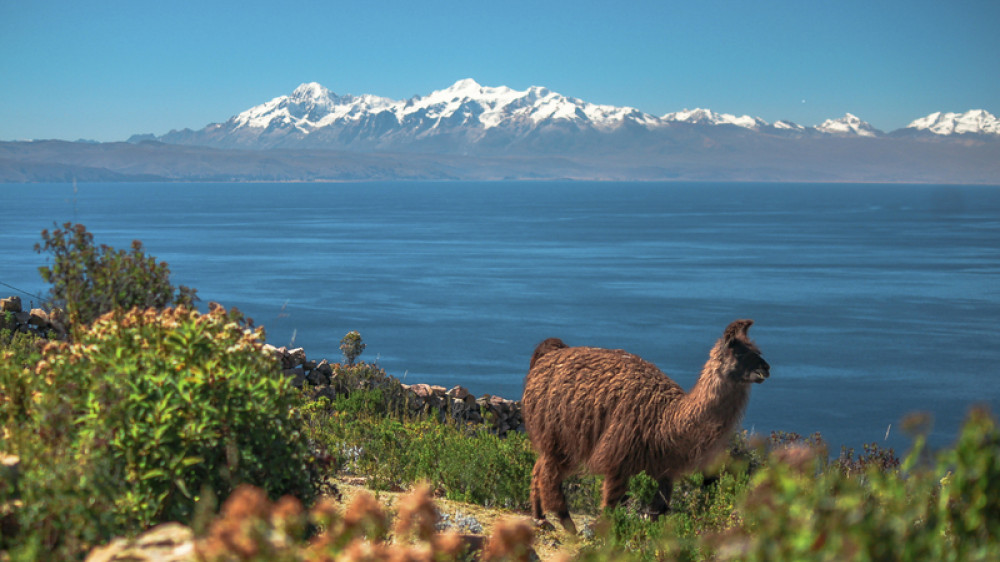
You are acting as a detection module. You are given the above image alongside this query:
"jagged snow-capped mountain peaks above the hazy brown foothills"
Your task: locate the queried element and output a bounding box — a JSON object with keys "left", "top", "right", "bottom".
{"left": 143, "top": 79, "right": 1000, "bottom": 154}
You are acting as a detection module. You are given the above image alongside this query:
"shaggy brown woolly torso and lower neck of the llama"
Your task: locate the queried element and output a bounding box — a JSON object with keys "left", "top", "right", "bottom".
{"left": 523, "top": 347, "right": 749, "bottom": 478}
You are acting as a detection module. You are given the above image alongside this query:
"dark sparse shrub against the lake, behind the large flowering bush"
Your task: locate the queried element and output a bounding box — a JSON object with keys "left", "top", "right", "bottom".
{"left": 35, "top": 223, "right": 195, "bottom": 327}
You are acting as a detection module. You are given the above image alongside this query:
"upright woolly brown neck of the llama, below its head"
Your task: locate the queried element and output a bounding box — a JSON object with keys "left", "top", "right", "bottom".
{"left": 660, "top": 353, "right": 750, "bottom": 465}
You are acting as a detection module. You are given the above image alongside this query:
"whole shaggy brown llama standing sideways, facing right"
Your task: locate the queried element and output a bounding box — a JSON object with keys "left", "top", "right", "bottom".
{"left": 522, "top": 320, "right": 770, "bottom": 533}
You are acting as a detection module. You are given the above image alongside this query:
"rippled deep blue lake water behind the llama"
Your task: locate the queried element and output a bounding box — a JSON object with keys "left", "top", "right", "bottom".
{"left": 0, "top": 182, "right": 1000, "bottom": 450}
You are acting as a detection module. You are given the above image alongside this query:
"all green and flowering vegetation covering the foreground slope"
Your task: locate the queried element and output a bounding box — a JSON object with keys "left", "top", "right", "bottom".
{"left": 0, "top": 225, "right": 1000, "bottom": 560}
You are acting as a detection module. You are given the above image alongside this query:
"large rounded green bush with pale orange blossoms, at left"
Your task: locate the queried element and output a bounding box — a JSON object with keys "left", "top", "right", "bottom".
{"left": 0, "top": 307, "right": 316, "bottom": 552}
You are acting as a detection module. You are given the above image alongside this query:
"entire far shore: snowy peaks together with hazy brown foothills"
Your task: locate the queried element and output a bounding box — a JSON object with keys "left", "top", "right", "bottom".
{"left": 0, "top": 79, "right": 1000, "bottom": 185}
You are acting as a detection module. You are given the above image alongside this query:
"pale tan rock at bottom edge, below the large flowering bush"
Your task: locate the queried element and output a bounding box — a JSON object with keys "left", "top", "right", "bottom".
{"left": 86, "top": 523, "right": 198, "bottom": 562}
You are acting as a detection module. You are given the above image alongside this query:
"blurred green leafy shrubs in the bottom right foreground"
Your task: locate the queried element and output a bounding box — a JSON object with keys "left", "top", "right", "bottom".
{"left": 647, "top": 410, "right": 1000, "bottom": 560}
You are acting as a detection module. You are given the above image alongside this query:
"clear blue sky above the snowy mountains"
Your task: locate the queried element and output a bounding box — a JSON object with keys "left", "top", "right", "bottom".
{"left": 0, "top": 0, "right": 1000, "bottom": 141}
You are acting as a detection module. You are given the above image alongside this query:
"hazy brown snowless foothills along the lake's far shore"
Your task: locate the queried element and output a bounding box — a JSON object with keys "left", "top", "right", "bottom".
{"left": 0, "top": 133, "right": 1000, "bottom": 185}
